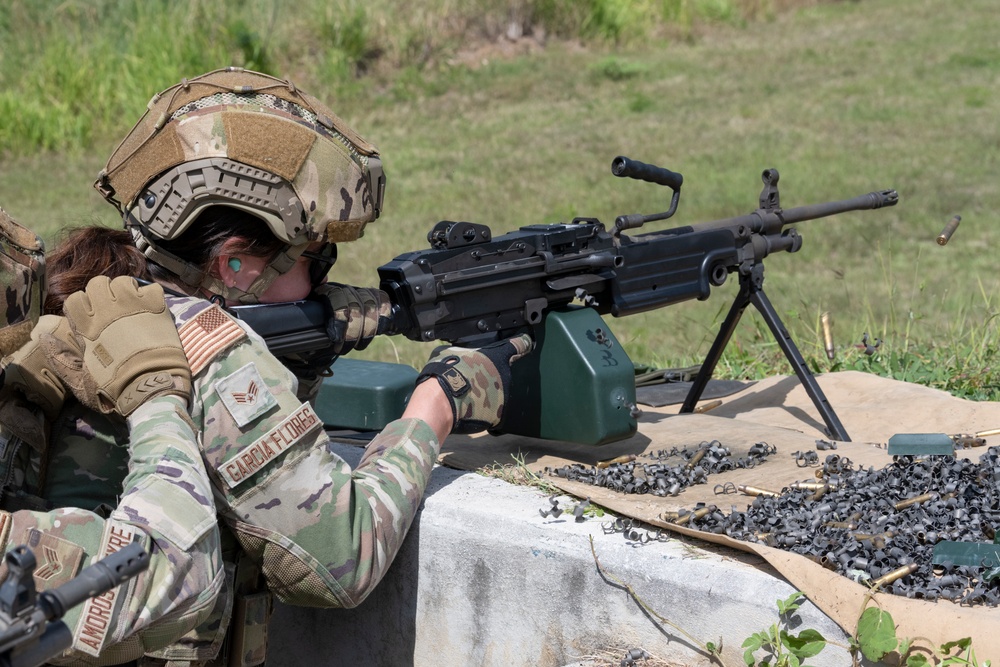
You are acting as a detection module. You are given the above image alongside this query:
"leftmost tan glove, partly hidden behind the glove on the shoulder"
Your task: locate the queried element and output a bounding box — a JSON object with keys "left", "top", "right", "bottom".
{"left": 0, "top": 315, "right": 73, "bottom": 420}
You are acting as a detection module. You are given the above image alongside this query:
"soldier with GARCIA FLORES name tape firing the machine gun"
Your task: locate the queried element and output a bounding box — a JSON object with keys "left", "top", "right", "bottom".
{"left": 37, "top": 68, "right": 532, "bottom": 665}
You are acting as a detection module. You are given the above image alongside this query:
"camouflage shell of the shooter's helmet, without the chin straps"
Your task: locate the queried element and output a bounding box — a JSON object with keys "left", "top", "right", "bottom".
{"left": 95, "top": 67, "right": 385, "bottom": 245}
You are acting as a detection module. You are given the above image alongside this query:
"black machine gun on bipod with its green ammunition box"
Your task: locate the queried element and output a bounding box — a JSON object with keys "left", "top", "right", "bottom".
{"left": 233, "top": 157, "right": 898, "bottom": 444}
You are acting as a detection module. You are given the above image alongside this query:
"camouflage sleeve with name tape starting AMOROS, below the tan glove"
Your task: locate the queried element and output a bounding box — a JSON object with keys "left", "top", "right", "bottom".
{"left": 5, "top": 396, "right": 225, "bottom": 664}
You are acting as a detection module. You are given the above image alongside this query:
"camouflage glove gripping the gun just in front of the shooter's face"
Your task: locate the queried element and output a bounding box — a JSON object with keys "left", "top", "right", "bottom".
{"left": 315, "top": 283, "right": 392, "bottom": 354}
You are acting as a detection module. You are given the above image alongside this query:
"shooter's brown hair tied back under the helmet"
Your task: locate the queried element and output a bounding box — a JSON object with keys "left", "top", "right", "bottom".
{"left": 45, "top": 206, "right": 284, "bottom": 315}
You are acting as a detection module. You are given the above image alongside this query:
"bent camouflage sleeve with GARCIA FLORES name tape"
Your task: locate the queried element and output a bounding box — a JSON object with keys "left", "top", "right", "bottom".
{"left": 189, "top": 318, "right": 440, "bottom": 607}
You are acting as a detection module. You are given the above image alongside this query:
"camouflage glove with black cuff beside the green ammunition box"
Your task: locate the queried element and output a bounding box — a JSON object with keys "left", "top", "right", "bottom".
{"left": 417, "top": 334, "right": 534, "bottom": 433}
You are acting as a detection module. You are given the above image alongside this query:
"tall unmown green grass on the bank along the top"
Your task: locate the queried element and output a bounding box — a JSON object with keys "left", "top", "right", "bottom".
{"left": 0, "top": 0, "right": 804, "bottom": 154}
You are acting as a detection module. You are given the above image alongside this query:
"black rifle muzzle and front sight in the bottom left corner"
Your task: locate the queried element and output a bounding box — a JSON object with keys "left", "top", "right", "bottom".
{"left": 0, "top": 544, "right": 149, "bottom": 667}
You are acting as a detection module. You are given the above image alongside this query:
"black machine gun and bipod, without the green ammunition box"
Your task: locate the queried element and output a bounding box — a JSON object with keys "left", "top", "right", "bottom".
{"left": 232, "top": 157, "right": 898, "bottom": 441}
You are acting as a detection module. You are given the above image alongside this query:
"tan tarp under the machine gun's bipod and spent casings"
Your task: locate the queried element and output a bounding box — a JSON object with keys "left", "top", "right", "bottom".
{"left": 442, "top": 371, "right": 1000, "bottom": 660}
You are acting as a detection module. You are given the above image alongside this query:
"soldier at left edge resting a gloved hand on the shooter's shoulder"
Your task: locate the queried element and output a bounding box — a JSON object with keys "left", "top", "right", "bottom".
{"left": 0, "top": 232, "right": 225, "bottom": 665}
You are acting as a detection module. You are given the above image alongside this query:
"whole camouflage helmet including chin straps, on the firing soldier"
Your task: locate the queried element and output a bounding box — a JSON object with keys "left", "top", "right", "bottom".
{"left": 94, "top": 67, "right": 385, "bottom": 303}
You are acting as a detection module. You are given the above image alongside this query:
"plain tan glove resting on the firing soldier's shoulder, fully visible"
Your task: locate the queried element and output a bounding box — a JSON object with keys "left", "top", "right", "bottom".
{"left": 46, "top": 276, "right": 191, "bottom": 417}
